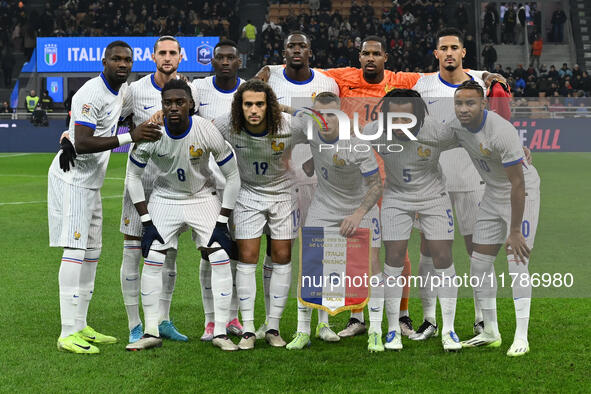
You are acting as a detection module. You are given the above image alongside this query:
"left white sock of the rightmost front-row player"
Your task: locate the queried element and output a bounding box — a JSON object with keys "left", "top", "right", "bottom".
{"left": 470, "top": 252, "right": 500, "bottom": 337}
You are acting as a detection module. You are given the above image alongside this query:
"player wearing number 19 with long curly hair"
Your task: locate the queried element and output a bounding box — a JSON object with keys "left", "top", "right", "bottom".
{"left": 214, "top": 80, "right": 306, "bottom": 349}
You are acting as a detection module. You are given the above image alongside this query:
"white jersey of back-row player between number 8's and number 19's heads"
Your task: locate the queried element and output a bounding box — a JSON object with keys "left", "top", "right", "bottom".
{"left": 191, "top": 75, "right": 244, "bottom": 120}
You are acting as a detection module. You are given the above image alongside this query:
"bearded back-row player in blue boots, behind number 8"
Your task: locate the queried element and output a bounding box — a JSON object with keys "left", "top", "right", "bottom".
{"left": 119, "top": 36, "right": 195, "bottom": 343}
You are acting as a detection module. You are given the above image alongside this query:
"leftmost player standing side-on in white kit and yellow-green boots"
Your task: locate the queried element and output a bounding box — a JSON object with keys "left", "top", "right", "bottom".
{"left": 47, "top": 41, "right": 160, "bottom": 354}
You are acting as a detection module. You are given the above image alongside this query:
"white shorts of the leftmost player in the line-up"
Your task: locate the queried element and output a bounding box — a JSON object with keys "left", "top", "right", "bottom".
{"left": 47, "top": 174, "right": 103, "bottom": 249}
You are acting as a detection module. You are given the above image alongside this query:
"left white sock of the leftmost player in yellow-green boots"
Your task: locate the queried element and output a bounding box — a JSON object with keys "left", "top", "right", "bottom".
{"left": 58, "top": 248, "right": 86, "bottom": 338}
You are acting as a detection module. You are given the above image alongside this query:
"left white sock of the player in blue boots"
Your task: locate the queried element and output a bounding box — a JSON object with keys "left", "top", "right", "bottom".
{"left": 120, "top": 240, "right": 142, "bottom": 330}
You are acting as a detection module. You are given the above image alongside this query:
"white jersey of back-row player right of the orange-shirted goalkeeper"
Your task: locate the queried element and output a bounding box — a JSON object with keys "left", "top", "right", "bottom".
{"left": 413, "top": 71, "right": 486, "bottom": 192}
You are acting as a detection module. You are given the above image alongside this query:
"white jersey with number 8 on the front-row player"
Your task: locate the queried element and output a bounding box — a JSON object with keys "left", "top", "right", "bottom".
{"left": 129, "top": 116, "right": 233, "bottom": 204}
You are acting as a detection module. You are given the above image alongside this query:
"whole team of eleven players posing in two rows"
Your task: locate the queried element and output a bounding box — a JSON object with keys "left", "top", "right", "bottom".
{"left": 48, "top": 28, "right": 540, "bottom": 356}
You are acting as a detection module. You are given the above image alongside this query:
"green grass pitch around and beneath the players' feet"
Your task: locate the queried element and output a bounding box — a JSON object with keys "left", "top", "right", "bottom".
{"left": 0, "top": 153, "right": 591, "bottom": 392}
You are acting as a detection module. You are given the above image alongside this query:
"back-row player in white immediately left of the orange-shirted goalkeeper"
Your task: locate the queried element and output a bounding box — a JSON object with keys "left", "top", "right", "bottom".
{"left": 256, "top": 31, "right": 339, "bottom": 339}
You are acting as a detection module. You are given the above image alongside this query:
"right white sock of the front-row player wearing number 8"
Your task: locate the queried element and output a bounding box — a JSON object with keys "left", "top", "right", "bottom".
{"left": 209, "top": 249, "right": 232, "bottom": 337}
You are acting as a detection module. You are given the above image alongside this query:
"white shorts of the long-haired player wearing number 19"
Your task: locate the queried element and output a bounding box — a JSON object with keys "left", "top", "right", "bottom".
{"left": 233, "top": 197, "right": 297, "bottom": 240}
